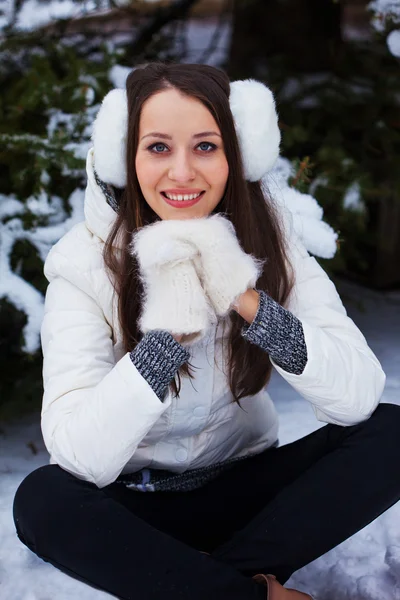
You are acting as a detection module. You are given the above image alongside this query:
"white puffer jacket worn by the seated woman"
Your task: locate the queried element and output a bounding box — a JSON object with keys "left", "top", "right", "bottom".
{"left": 42, "top": 151, "right": 385, "bottom": 488}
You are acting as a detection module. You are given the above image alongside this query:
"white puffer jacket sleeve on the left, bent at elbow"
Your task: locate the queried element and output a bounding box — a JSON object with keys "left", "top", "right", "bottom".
{"left": 41, "top": 252, "right": 175, "bottom": 488}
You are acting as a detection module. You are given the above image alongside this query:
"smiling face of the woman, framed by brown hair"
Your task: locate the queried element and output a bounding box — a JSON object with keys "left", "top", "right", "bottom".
{"left": 135, "top": 89, "right": 229, "bottom": 220}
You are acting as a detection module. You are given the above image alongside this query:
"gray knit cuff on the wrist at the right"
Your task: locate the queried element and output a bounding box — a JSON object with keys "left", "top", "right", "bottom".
{"left": 242, "top": 290, "right": 307, "bottom": 375}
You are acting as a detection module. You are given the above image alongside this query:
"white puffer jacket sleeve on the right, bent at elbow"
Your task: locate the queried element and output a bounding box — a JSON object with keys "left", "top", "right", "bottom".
{"left": 271, "top": 236, "right": 386, "bottom": 425}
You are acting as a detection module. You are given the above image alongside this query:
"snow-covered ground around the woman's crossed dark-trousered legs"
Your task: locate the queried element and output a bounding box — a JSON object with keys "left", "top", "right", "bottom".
{"left": 0, "top": 282, "right": 400, "bottom": 600}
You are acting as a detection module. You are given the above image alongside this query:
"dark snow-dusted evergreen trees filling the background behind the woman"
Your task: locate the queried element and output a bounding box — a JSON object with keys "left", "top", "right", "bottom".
{"left": 0, "top": 0, "right": 400, "bottom": 418}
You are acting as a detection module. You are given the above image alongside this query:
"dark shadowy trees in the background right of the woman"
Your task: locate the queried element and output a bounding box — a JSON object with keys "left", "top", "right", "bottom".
{"left": 229, "top": 0, "right": 400, "bottom": 288}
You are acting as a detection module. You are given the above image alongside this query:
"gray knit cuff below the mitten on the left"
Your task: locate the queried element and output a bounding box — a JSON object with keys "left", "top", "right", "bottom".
{"left": 130, "top": 330, "right": 190, "bottom": 402}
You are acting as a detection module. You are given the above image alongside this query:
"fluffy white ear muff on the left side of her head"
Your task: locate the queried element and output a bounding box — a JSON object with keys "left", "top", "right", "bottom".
{"left": 92, "top": 89, "right": 128, "bottom": 188}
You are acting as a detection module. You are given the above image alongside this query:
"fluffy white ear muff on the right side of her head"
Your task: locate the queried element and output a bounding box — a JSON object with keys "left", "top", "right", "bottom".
{"left": 229, "top": 79, "right": 281, "bottom": 181}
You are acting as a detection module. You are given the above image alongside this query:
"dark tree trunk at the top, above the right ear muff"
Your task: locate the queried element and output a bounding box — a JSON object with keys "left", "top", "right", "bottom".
{"left": 230, "top": 0, "right": 342, "bottom": 77}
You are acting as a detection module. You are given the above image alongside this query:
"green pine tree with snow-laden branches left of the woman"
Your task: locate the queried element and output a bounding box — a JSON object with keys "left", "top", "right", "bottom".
{"left": 0, "top": 36, "right": 116, "bottom": 418}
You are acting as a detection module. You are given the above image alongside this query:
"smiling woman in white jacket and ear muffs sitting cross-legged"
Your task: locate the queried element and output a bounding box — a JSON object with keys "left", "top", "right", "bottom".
{"left": 14, "top": 64, "right": 400, "bottom": 600}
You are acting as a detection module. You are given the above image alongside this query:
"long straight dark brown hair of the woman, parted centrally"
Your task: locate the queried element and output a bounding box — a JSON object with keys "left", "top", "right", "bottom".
{"left": 104, "top": 63, "right": 293, "bottom": 402}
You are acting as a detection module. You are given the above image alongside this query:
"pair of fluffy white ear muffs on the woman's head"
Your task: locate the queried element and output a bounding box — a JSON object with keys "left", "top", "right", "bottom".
{"left": 92, "top": 79, "right": 281, "bottom": 188}
